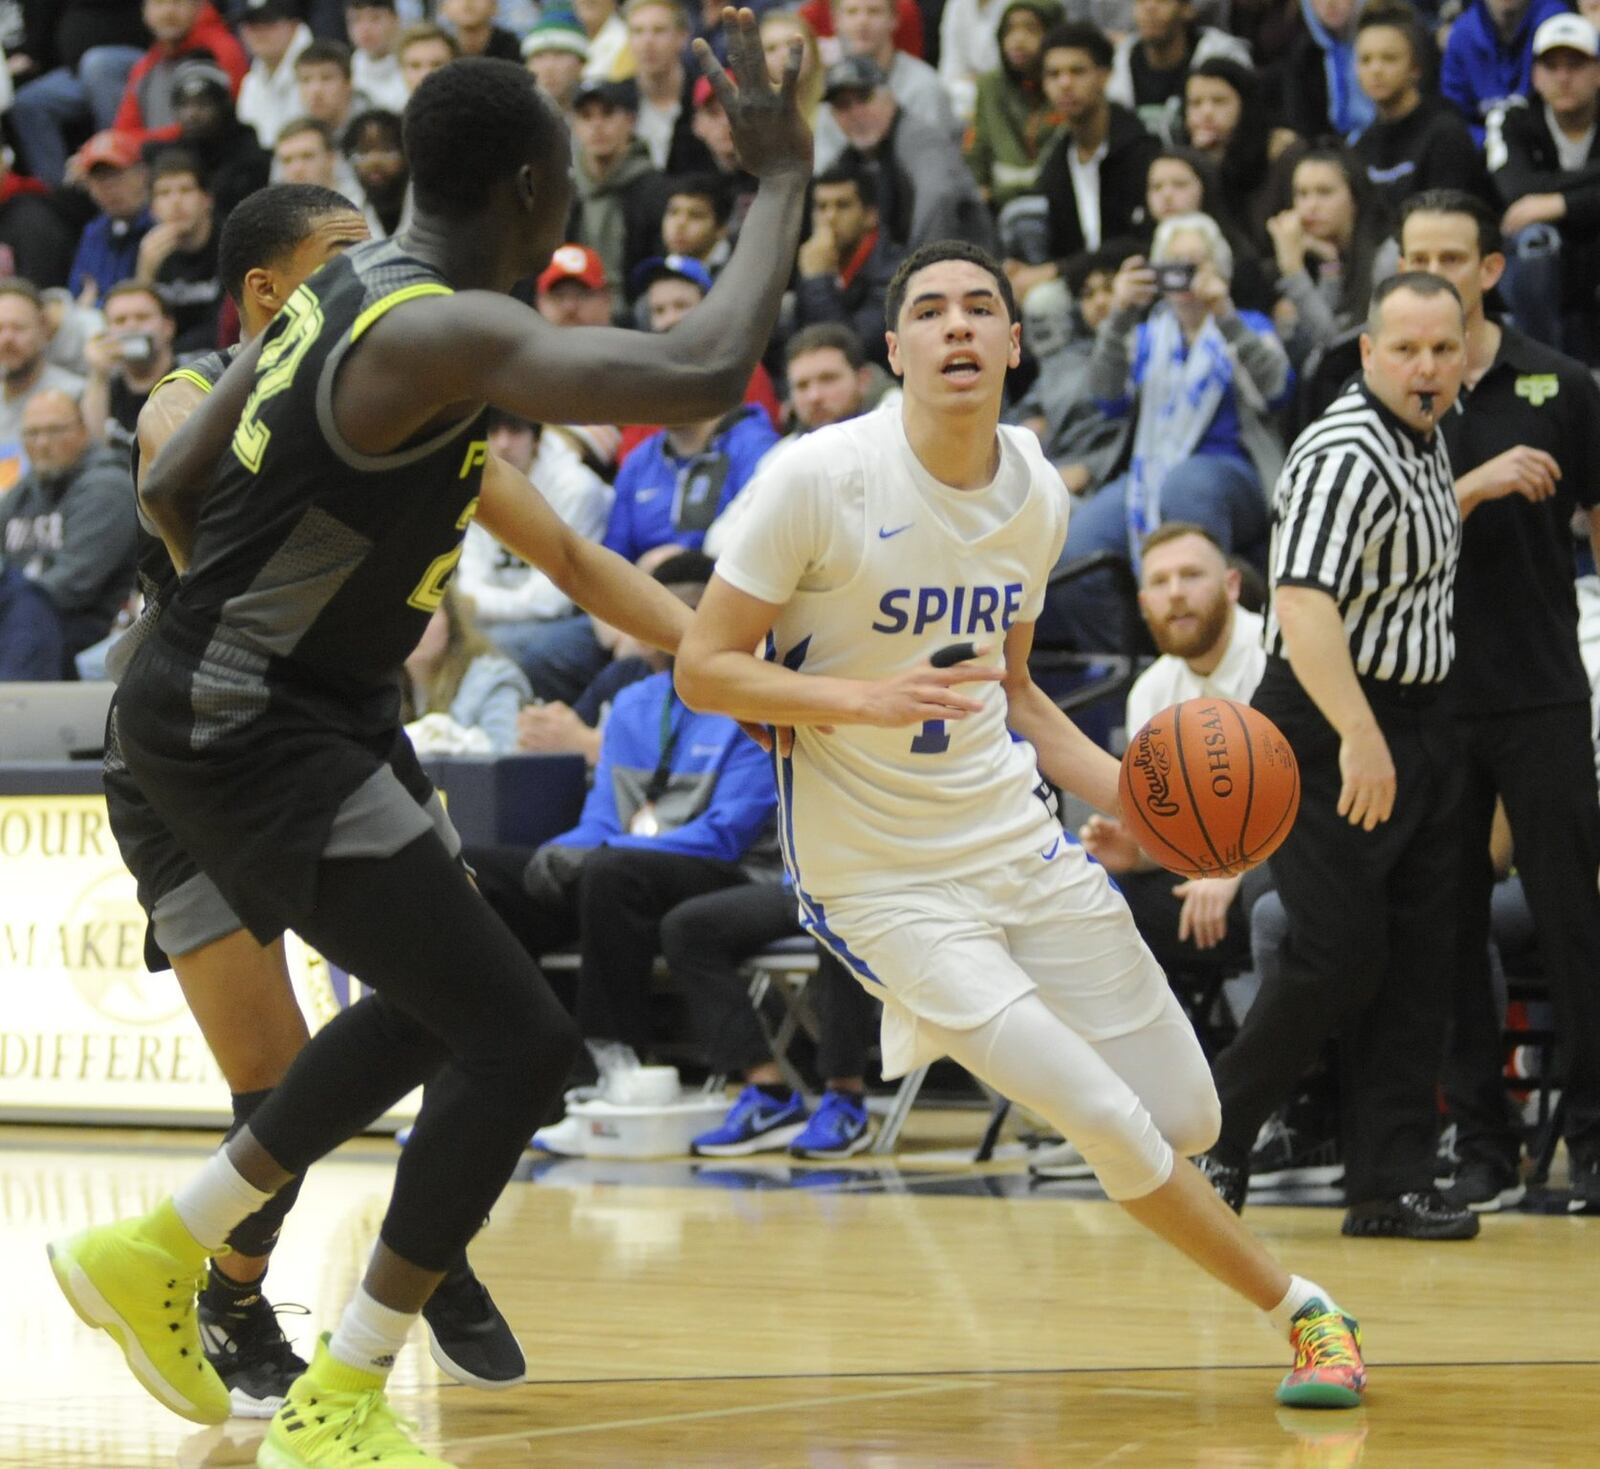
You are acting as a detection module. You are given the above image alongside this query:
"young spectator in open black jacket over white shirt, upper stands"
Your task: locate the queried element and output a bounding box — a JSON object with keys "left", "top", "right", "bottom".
{"left": 1019, "top": 22, "right": 1162, "bottom": 270}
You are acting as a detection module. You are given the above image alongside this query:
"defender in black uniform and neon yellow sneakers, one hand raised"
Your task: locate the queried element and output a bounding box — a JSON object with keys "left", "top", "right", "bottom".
{"left": 53, "top": 25, "right": 811, "bottom": 1469}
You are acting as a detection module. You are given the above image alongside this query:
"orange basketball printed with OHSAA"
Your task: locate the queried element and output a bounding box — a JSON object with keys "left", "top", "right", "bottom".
{"left": 1118, "top": 699, "right": 1299, "bottom": 877}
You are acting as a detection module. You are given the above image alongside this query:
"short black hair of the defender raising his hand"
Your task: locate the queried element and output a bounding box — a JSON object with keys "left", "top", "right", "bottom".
{"left": 405, "top": 56, "right": 566, "bottom": 216}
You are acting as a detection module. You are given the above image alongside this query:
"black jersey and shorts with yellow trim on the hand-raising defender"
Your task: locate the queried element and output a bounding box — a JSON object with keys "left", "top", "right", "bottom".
{"left": 118, "top": 240, "right": 488, "bottom": 943}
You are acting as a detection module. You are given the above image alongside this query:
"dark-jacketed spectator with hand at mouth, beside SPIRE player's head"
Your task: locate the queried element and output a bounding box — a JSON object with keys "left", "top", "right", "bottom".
{"left": 795, "top": 163, "right": 906, "bottom": 366}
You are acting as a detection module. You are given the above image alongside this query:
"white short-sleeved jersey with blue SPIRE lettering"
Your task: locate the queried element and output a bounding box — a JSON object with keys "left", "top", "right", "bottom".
{"left": 717, "top": 405, "right": 1069, "bottom": 922}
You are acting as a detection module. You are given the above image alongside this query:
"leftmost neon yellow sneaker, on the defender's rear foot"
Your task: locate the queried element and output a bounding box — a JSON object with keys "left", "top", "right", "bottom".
{"left": 48, "top": 1199, "right": 230, "bottom": 1423}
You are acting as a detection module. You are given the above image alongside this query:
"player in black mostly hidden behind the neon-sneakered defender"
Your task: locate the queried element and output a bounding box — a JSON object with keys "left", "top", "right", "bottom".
{"left": 104, "top": 184, "right": 526, "bottom": 1418}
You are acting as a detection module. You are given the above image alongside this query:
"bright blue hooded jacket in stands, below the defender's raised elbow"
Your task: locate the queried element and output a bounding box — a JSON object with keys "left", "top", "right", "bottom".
{"left": 603, "top": 403, "right": 778, "bottom": 562}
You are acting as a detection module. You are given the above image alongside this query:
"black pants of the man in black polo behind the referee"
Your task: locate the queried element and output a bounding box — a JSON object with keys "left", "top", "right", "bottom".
{"left": 1445, "top": 704, "right": 1600, "bottom": 1170}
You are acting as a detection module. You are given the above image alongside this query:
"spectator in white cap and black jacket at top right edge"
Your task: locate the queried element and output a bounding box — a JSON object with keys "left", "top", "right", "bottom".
{"left": 1483, "top": 14, "right": 1600, "bottom": 366}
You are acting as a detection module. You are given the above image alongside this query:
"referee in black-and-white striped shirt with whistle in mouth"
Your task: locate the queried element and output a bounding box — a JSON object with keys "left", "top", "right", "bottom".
{"left": 1202, "top": 272, "right": 1478, "bottom": 1240}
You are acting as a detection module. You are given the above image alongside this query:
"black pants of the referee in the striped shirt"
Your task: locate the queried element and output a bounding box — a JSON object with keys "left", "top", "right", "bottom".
{"left": 1214, "top": 659, "right": 1461, "bottom": 1203}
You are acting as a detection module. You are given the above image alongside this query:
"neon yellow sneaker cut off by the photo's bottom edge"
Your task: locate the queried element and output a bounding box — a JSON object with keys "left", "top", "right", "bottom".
{"left": 256, "top": 1333, "right": 454, "bottom": 1469}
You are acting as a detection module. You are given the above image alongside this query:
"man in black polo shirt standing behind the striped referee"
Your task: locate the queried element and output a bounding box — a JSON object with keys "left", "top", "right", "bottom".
{"left": 1400, "top": 189, "right": 1600, "bottom": 1210}
